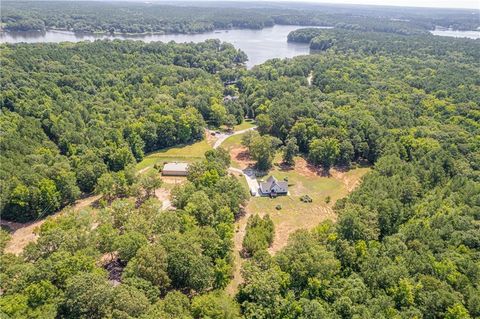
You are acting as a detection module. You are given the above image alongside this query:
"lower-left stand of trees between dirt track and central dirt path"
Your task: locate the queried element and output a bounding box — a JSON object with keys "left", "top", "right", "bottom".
{"left": 0, "top": 150, "right": 251, "bottom": 319}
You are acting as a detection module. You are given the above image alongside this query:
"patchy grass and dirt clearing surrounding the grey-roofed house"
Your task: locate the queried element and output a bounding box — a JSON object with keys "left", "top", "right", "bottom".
{"left": 247, "top": 157, "right": 369, "bottom": 253}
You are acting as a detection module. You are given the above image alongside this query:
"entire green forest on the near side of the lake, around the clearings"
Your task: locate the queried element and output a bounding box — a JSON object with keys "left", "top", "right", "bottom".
{"left": 0, "top": 3, "right": 480, "bottom": 319}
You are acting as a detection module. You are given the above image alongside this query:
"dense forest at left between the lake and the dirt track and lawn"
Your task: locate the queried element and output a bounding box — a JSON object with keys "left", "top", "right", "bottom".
{"left": 0, "top": 40, "right": 246, "bottom": 221}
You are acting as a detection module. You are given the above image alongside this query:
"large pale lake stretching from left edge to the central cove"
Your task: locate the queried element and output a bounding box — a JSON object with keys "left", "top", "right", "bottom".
{"left": 0, "top": 25, "right": 330, "bottom": 68}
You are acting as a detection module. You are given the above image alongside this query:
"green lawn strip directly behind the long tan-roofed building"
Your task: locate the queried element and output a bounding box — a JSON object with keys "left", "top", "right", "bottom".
{"left": 136, "top": 140, "right": 212, "bottom": 170}
